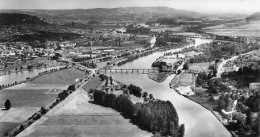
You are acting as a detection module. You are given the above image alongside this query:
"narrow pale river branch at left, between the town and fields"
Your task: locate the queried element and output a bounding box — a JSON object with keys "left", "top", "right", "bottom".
{"left": 0, "top": 67, "right": 60, "bottom": 85}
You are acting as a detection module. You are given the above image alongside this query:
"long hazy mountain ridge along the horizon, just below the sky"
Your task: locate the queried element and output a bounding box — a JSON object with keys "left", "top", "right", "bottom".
{"left": 0, "top": 7, "right": 203, "bottom": 23}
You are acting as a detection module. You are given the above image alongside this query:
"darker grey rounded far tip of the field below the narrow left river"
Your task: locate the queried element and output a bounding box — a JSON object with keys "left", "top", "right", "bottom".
{"left": 29, "top": 68, "right": 85, "bottom": 85}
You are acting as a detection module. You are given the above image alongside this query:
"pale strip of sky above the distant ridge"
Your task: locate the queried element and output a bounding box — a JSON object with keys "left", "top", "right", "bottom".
{"left": 0, "top": 0, "right": 260, "bottom": 14}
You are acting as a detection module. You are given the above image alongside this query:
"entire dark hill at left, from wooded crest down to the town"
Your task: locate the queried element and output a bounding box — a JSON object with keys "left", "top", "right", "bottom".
{"left": 0, "top": 13, "right": 80, "bottom": 42}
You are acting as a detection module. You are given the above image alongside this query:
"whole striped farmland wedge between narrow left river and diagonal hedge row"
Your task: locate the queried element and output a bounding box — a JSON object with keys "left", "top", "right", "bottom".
{"left": 0, "top": 68, "right": 85, "bottom": 135}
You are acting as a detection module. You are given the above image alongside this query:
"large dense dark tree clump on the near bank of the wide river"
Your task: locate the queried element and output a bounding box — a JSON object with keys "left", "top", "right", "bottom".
{"left": 93, "top": 89, "right": 185, "bottom": 137}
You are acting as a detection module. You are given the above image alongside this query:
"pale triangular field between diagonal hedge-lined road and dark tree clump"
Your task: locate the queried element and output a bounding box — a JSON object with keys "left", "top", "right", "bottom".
{"left": 18, "top": 78, "right": 152, "bottom": 137}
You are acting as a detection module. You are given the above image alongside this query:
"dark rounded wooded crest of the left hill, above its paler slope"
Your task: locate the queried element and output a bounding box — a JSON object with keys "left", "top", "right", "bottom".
{"left": 0, "top": 13, "right": 47, "bottom": 25}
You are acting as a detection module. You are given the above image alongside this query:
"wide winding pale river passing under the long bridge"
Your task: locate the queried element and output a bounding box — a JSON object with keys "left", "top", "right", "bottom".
{"left": 108, "top": 39, "right": 231, "bottom": 137}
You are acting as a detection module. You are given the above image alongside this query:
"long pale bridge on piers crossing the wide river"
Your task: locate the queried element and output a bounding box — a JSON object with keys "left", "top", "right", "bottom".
{"left": 99, "top": 69, "right": 159, "bottom": 74}
